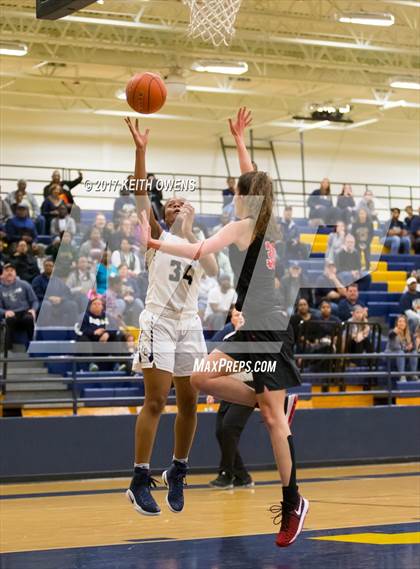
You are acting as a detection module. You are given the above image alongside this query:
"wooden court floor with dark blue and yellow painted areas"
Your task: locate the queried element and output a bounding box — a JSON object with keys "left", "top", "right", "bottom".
{"left": 0, "top": 463, "right": 420, "bottom": 569}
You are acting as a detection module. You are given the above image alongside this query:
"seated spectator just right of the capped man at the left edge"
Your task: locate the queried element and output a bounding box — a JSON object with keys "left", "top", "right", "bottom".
{"left": 32, "top": 258, "right": 78, "bottom": 326}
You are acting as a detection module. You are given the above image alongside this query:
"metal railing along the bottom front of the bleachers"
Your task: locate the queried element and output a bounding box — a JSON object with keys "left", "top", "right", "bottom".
{"left": 0, "top": 353, "right": 420, "bottom": 415}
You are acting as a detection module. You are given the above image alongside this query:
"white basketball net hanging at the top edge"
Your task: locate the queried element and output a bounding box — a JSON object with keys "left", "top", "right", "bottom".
{"left": 183, "top": 0, "right": 242, "bottom": 47}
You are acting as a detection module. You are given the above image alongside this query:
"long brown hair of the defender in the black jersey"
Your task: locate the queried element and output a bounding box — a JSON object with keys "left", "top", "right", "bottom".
{"left": 238, "top": 172, "right": 278, "bottom": 239}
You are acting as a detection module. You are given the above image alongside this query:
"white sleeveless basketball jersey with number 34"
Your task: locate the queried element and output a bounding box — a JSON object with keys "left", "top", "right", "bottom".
{"left": 146, "top": 231, "right": 203, "bottom": 319}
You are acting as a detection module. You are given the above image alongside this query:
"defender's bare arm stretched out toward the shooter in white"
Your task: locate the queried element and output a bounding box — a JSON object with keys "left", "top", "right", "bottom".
{"left": 140, "top": 211, "right": 244, "bottom": 260}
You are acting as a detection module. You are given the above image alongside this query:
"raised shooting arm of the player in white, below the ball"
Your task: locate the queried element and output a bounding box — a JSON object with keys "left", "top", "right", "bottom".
{"left": 124, "top": 117, "right": 162, "bottom": 239}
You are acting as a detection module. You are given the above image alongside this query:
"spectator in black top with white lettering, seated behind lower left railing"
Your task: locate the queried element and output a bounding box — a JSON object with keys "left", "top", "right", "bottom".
{"left": 77, "top": 298, "right": 125, "bottom": 371}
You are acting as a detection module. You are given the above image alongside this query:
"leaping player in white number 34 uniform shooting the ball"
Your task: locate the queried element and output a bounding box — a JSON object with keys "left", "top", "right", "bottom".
{"left": 126, "top": 118, "right": 218, "bottom": 516}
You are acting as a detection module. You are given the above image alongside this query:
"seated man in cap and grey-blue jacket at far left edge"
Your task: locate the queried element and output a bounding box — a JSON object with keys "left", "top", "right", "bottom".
{"left": 0, "top": 263, "right": 39, "bottom": 350}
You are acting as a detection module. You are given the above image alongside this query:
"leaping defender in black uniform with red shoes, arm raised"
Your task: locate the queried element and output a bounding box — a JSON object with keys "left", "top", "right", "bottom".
{"left": 141, "top": 108, "right": 309, "bottom": 547}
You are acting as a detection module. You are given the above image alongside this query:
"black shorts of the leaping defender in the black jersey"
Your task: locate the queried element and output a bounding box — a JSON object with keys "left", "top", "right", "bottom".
{"left": 217, "top": 318, "right": 301, "bottom": 393}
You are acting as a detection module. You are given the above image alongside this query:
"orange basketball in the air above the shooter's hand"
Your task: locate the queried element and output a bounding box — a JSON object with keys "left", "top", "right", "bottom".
{"left": 125, "top": 72, "right": 166, "bottom": 115}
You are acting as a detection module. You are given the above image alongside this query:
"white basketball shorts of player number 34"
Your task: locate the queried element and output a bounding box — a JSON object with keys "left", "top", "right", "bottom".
{"left": 133, "top": 309, "right": 207, "bottom": 377}
